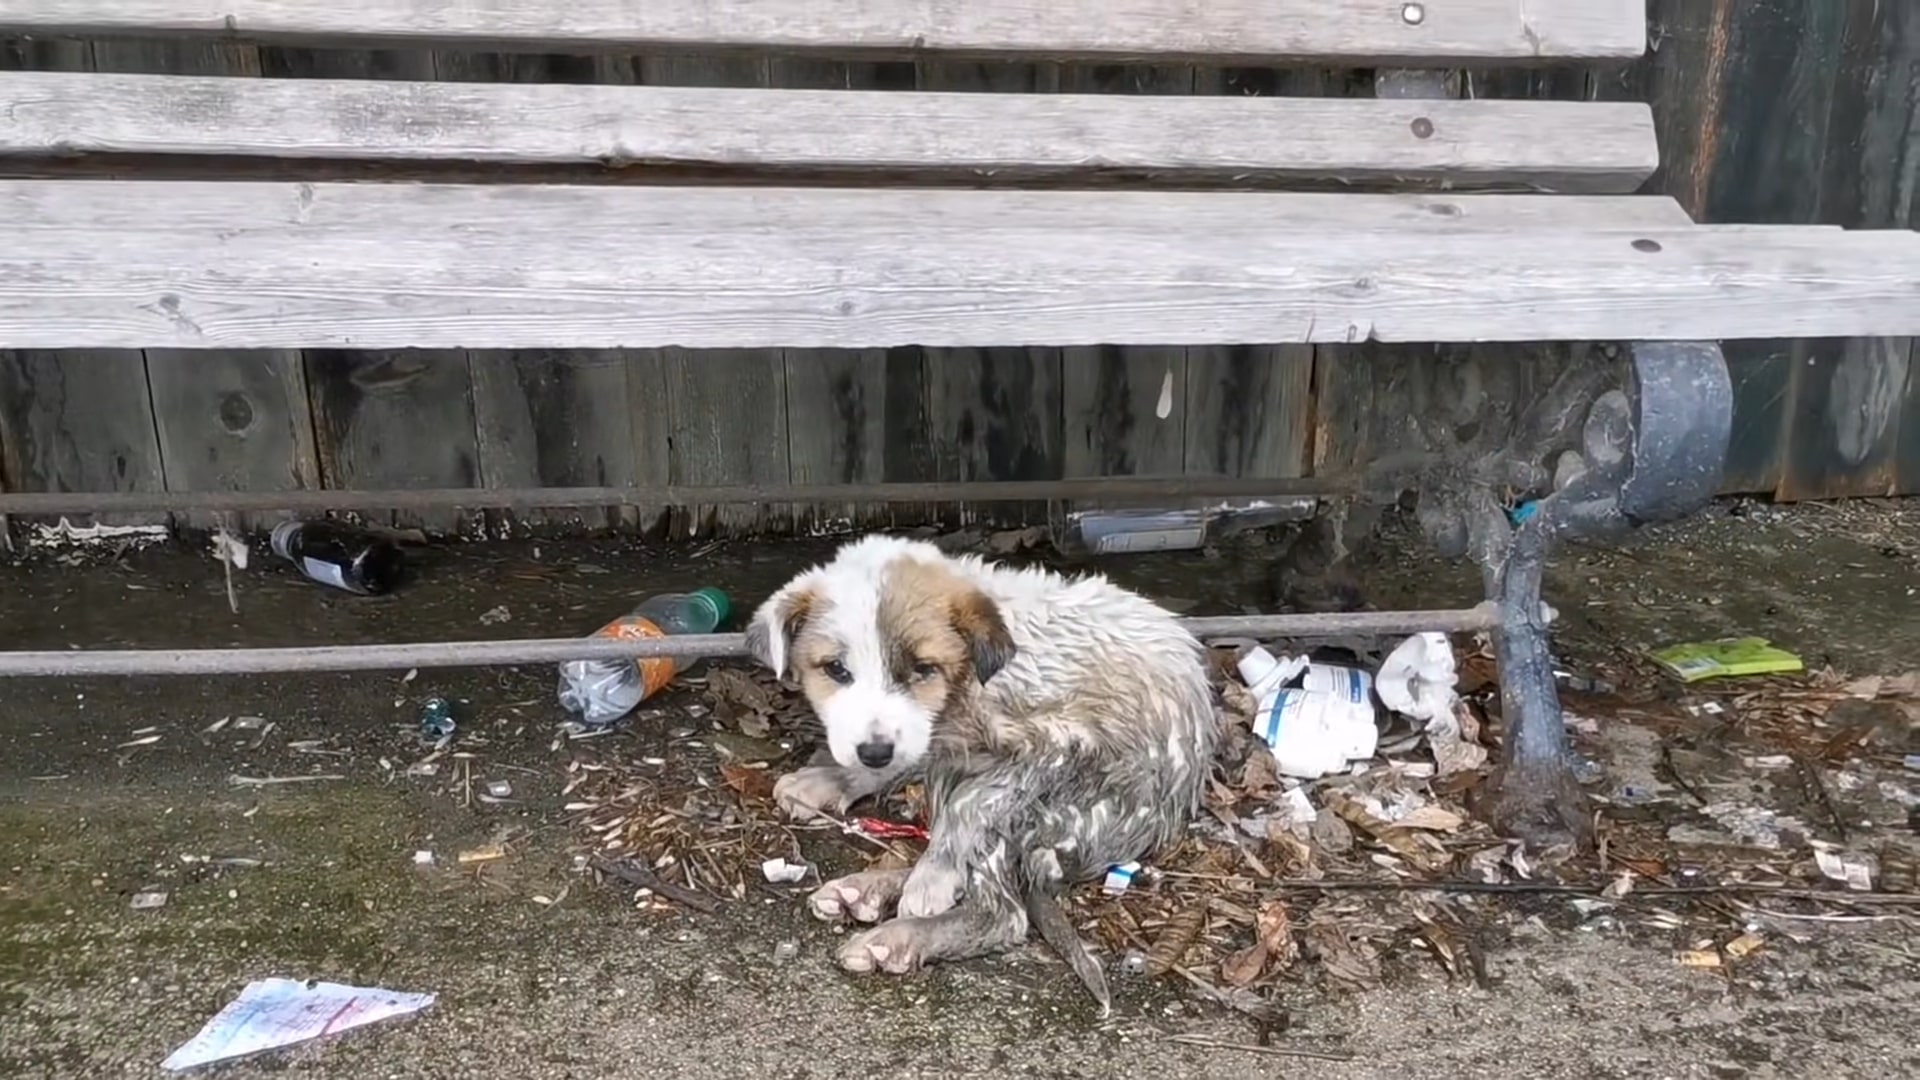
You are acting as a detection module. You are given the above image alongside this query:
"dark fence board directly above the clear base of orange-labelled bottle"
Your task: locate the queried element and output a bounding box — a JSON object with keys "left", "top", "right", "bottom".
{"left": 468, "top": 352, "right": 639, "bottom": 530}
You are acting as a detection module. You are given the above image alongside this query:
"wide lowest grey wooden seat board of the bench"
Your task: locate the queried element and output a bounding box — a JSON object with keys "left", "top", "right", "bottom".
{"left": 0, "top": 181, "right": 1920, "bottom": 348}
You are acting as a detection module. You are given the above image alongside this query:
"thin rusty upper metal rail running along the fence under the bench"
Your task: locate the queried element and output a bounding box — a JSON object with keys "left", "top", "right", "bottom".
{"left": 0, "top": 477, "right": 1354, "bottom": 515}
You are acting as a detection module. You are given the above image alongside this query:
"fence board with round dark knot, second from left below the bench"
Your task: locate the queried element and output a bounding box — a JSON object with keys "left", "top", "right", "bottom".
{"left": 146, "top": 350, "right": 321, "bottom": 528}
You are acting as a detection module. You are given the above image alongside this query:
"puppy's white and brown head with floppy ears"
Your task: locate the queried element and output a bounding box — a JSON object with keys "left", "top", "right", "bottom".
{"left": 747, "top": 545, "right": 1014, "bottom": 771}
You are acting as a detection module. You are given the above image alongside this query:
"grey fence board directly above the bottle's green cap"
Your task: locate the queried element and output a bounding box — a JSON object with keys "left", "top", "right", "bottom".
{"left": 664, "top": 348, "right": 793, "bottom": 536}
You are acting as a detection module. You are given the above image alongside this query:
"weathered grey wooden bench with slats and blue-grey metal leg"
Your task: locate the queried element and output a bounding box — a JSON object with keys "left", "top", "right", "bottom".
{"left": 0, "top": 0, "right": 1920, "bottom": 840}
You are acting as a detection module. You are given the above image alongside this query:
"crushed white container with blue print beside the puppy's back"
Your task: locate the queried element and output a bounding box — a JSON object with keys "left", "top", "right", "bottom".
{"left": 1240, "top": 646, "right": 1380, "bottom": 780}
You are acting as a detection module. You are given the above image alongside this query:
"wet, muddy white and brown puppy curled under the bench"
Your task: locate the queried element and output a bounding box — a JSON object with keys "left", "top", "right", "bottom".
{"left": 747, "top": 536, "right": 1219, "bottom": 1007}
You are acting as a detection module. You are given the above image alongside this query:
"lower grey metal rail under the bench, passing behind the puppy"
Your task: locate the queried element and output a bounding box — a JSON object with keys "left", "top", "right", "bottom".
{"left": 0, "top": 603, "right": 1500, "bottom": 678}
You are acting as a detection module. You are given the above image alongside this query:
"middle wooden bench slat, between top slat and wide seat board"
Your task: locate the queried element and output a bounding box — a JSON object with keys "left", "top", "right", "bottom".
{"left": 0, "top": 71, "right": 1659, "bottom": 192}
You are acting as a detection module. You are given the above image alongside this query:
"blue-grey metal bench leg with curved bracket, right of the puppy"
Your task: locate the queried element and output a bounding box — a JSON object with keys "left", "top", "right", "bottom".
{"left": 1453, "top": 342, "right": 1734, "bottom": 847}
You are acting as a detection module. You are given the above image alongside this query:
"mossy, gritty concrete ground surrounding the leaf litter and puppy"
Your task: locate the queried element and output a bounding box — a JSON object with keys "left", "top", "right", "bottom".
{"left": 0, "top": 507, "right": 1920, "bottom": 1080}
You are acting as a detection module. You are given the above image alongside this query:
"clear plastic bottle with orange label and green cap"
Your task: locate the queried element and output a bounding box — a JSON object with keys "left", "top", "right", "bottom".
{"left": 561, "top": 588, "right": 732, "bottom": 728}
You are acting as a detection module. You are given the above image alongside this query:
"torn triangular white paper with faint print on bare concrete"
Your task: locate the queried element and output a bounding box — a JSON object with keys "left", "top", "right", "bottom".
{"left": 159, "top": 978, "right": 434, "bottom": 1072}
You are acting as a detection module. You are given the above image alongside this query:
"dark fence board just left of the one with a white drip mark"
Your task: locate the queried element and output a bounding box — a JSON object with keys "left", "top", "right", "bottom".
{"left": 927, "top": 348, "right": 1066, "bottom": 521}
